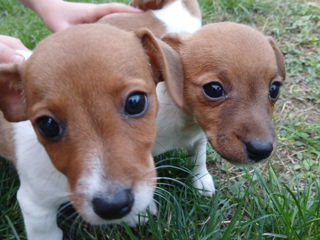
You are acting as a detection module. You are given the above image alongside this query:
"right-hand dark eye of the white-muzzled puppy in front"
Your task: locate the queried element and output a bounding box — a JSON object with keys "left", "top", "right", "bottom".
{"left": 124, "top": 92, "right": 148, "bottom": 117}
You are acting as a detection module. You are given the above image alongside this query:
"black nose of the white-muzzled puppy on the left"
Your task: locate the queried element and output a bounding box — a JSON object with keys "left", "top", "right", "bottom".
{"left": 92, "top": 189, "right": 134, "bottom": 220}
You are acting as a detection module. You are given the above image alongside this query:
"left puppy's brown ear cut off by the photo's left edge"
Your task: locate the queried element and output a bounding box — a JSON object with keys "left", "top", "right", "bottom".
{"left": 0, "top": 64, "right": 27, "bottom": 122}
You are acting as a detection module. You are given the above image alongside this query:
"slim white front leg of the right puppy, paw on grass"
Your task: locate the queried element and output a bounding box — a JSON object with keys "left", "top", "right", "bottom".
{"left": 188, "top": 138, "right": 215, "bottom": 197}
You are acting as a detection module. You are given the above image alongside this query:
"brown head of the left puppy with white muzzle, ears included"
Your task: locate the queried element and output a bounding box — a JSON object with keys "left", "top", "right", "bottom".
{"left": 0, "top": 24, "right": 182, "bottom": 224}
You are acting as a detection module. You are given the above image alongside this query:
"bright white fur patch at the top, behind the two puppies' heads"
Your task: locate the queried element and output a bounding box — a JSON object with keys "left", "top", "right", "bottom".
{"left": 152, "top": 0, "right": 201, "bottom": 33}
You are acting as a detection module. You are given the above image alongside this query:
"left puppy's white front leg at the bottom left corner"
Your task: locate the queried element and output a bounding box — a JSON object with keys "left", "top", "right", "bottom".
{"left": 17, "top": 185, "right": 63, "bottom": 240}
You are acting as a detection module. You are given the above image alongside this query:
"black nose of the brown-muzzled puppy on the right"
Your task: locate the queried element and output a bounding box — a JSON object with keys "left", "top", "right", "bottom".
{"left": 246, "top": 141, "right": 273, "bottom": 162}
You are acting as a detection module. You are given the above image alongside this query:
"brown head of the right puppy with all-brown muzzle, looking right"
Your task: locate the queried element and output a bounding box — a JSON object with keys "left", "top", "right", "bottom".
{"left": 164, "top": 22, "right": 285, "bottom": 164}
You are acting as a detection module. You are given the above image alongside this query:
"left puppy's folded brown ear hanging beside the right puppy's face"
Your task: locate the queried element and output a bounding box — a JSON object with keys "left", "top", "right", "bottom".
{"left": 136, "top": 29, "right": 184, "bottom": 108}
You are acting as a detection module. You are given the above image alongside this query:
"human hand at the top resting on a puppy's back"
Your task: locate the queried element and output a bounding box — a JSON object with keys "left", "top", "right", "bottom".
{"left": 32, "top": 0, "right": 141, "bottom": 32}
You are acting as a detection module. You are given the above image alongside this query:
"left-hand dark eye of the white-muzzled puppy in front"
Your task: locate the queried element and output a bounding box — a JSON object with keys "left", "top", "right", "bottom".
{"left": 36, "top": 116, "right": 63, "bottom": 141}
